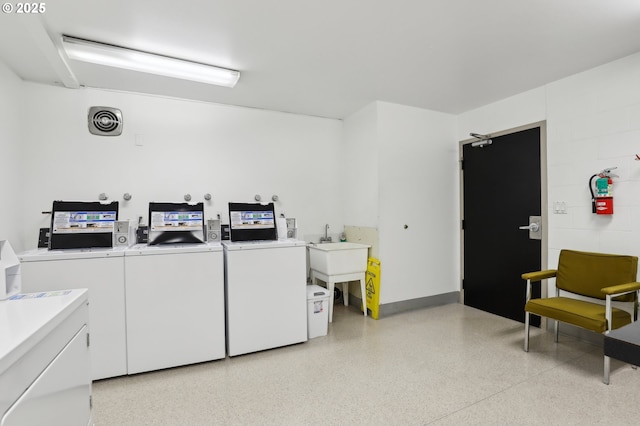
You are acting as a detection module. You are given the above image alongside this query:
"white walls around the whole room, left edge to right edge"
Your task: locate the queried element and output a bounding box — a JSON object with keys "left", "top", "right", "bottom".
{"left": 10, "top": 50, "right": 640, "bottom": 310}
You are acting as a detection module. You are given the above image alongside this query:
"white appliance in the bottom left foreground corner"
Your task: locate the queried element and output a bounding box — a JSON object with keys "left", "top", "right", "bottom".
{"left": 0, "top": 289, "right": 92, "bottom": 426}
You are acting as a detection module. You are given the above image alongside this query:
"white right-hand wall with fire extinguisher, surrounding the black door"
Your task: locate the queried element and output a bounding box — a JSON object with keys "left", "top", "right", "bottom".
{"left": 458, "top": 54, "right": 640, "bottom": 276}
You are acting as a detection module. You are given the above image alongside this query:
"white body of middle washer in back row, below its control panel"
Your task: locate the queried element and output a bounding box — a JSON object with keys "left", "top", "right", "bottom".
{"left": 125, "top": 243, "right": 226, "bottom": 374}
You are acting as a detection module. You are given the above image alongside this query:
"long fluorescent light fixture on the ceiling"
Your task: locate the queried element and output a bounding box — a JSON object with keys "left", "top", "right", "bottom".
{"left": 62, "top": 35, "right": 240, "bottom": 87}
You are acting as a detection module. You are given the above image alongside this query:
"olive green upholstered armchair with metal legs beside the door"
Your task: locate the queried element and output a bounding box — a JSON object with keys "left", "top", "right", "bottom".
{"left": 522, "top": 250, "right": 640, "bottom": 384}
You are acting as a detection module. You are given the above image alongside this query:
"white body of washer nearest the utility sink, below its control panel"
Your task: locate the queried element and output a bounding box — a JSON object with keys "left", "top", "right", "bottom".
{"left": 222, "top": 240, "right": 307, "bottom": 356}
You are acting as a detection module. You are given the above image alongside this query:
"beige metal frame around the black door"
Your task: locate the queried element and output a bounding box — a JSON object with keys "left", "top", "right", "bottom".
{"left": 458, "top": 120, "right": 549, "bottom": 316}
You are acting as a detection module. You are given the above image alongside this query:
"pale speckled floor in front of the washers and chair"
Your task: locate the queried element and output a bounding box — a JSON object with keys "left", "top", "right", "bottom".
{"left": 93, "top": 304, "right": 640, "bottom": 426}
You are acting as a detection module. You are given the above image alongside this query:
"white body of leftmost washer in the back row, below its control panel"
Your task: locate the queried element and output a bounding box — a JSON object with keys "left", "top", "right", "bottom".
{"left": 18, "top": 247, "right": 127, "bottom": 380}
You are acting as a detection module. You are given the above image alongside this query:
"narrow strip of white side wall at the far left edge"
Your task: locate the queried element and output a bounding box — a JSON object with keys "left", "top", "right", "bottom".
{"left": 0, "top": 61, "right": 25, "bottom": 252}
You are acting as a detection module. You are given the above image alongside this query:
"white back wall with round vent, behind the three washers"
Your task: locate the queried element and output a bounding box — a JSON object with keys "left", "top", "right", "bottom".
{"left": 18, "top": 83, "right": 344, "bottom": 248}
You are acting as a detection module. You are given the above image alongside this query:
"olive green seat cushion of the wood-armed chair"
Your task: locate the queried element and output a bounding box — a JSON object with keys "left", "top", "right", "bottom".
{"left": 524, "top": 297, "right": 631, "bottom": 333}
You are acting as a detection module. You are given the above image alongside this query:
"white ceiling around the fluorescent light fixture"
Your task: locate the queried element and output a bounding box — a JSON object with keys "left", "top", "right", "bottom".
{"left": 0, "top": 0, "right": 640, "bottom": 118}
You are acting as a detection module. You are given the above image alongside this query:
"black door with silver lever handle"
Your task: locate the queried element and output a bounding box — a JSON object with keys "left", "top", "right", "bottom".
{"left": 462, "top": 127, "right": 542, "bottom": 325}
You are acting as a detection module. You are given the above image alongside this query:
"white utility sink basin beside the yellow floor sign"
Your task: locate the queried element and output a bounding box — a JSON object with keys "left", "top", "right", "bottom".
{"left": 307, "top": 243, "right": 371, "bottom": 275}
